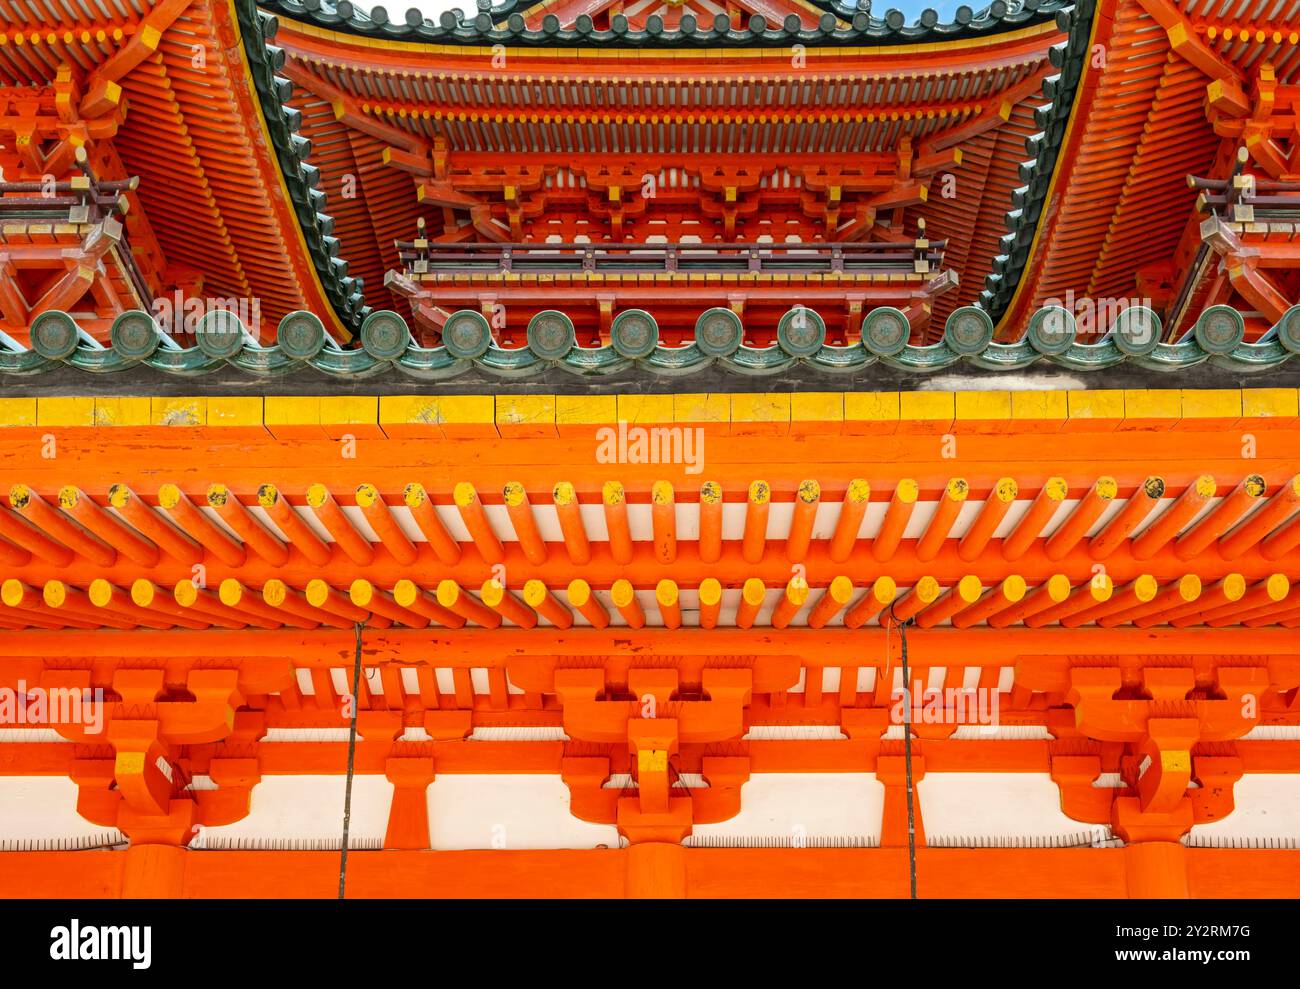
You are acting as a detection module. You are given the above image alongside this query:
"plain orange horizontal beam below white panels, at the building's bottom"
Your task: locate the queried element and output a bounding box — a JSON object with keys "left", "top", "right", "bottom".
{"left": 0, "top": 846, "right": 1300, "bottom": 899}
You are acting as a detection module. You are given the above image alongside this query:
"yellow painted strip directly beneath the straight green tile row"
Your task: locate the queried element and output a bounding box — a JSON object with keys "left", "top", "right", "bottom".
{"left": 0, "top": 387, "right": 1300, "bottom": 438}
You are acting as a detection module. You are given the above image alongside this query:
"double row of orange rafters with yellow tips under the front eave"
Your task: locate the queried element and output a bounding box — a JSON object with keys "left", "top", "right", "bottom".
{"left": 0, "top": 474, "right": 1300, "bottom": 628}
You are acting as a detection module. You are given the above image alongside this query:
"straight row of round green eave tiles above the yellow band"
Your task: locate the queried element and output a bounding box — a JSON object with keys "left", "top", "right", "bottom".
{"left": 12, "top": 297, "right": 1300, "bottom": 381}
